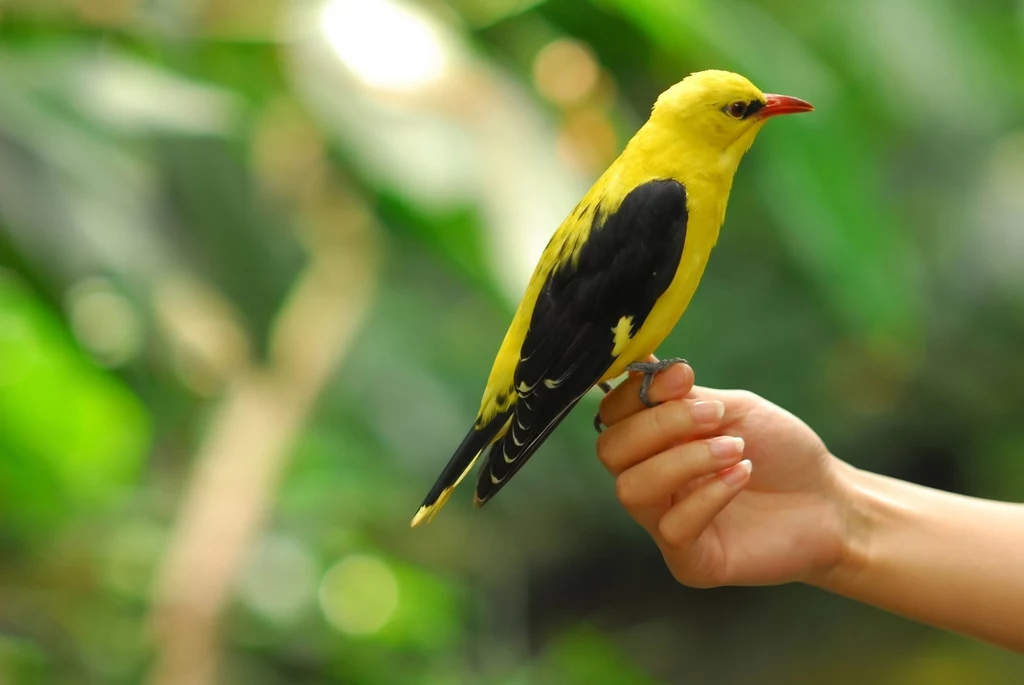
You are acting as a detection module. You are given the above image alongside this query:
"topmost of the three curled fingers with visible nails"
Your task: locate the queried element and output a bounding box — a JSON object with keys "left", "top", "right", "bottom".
{"left": 597, "top": 399, "right": 725, "bottom": 476}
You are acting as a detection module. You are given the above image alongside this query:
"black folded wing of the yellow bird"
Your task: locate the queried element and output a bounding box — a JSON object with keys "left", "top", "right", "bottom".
{"left": 475, "top": 180, "right": 687, "bottom": 505}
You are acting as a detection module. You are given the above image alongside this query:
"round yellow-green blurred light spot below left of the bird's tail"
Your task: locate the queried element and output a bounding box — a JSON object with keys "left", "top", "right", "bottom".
{"left": 319, "top": 554, "right": 398, "bottom": 635}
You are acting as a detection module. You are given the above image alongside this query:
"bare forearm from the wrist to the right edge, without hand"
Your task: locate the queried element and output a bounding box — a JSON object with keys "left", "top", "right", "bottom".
{"left": 818, "top": 464, "right": 1024, "bottom": 652}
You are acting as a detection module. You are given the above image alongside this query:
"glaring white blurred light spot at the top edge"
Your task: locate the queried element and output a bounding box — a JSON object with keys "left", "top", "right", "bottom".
{"left": 321, "top": 0, "right": 446, "bottom": 90}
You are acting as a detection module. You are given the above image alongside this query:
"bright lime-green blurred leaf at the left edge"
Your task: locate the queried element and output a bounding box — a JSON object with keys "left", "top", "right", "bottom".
{"left": 0, "top": 276, "right": 150, "bottom": 518}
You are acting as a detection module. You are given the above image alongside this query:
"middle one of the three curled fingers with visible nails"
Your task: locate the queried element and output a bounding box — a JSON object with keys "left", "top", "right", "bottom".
{"left": 615, "top": 435, "right": 743, "bottom": 511}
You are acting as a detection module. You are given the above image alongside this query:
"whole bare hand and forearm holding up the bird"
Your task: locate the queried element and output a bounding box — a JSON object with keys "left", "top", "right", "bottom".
{"left": 597, "top": 358, "right": 1024, "bottom": 653}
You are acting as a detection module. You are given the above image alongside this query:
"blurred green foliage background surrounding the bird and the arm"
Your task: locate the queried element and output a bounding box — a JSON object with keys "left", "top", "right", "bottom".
{"left": 0, "top": 0, "right": 1024, "bottom": 685}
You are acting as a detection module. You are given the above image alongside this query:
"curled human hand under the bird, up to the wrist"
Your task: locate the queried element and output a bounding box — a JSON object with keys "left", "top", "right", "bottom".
{"left": 597, "top": 365, "right": 852, "bottom": 588}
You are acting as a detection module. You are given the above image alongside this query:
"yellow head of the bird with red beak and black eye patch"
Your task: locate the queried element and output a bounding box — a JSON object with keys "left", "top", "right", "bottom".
{"left": 649, "top": 70, "right": 814, "bottom": 172}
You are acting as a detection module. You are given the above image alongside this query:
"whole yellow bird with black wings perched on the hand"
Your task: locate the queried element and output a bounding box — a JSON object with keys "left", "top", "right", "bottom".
{"left": 412, "top": 71, "right": 813, "bottom": 526}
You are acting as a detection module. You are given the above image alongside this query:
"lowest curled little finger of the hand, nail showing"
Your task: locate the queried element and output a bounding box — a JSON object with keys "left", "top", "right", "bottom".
{"left": 657, "top": 459, "right": 752, "bottom": 549}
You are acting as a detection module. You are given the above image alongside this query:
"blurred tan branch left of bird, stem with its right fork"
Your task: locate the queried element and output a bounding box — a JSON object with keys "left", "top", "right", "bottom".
{"left": 150, "top": 165, "right": 380, "bottom": 685}
